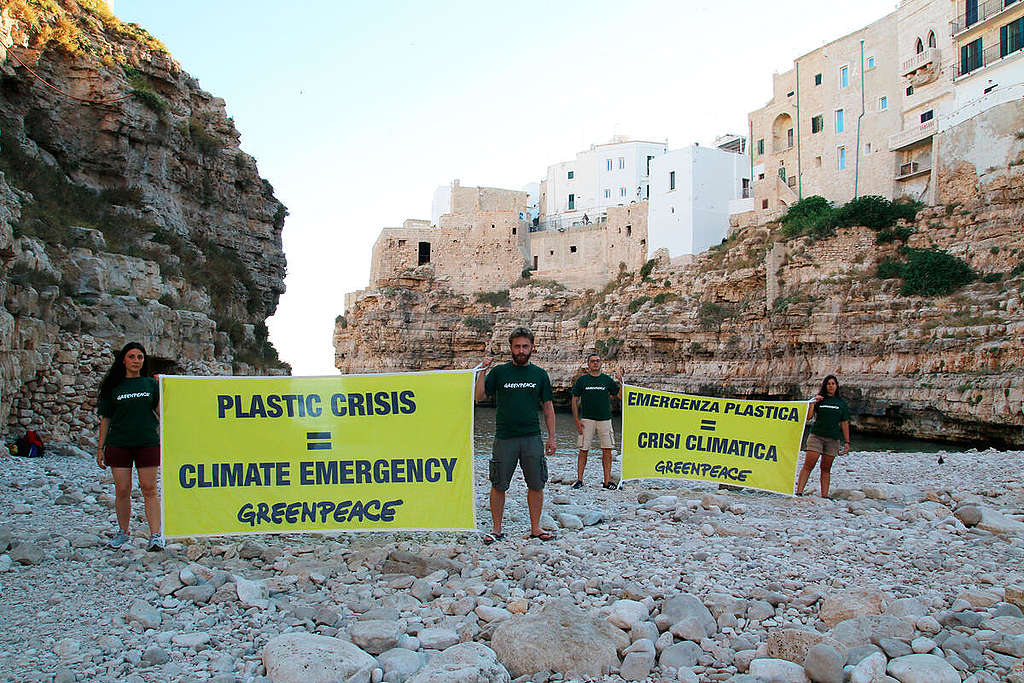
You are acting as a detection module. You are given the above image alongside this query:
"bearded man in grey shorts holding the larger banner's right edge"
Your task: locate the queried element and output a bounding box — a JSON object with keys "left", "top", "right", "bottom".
{"left": 475, "top": 327, "right": 555, "bottom": 544}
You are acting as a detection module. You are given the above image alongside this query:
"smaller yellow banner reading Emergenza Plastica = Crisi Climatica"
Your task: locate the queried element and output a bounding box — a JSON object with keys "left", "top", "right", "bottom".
{"left": 623, "top": 386, "right": 808, "bottom": 496}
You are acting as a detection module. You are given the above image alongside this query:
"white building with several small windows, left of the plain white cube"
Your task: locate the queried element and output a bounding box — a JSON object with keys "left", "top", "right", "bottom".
{"left": 541, "top": 136, "right": 668, "bottom": 228}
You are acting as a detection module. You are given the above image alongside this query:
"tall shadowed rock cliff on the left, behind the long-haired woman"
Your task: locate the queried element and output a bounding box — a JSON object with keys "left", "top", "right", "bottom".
{"left": 0, "top": 0, "right": 287, "bottom": 440}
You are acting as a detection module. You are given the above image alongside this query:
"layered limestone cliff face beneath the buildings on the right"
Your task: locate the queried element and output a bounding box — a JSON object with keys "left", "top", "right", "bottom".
{"left": 334, "top": 103, "right": 1024, "bottom": 447}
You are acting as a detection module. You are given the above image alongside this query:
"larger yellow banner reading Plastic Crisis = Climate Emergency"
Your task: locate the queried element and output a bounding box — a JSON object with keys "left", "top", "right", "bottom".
{"left": 161, "top": 371, "right": 475, "bottom": 537}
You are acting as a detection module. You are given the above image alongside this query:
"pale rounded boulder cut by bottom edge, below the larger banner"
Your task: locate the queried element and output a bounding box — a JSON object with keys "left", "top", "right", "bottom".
{"left": 263, "top": 633, "right": 376, "bottom": 683}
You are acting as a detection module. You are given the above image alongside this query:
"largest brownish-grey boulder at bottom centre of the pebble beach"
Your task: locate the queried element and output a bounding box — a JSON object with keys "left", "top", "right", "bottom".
{"left": 490, "top": 600, "right": 630, "bottom": 677}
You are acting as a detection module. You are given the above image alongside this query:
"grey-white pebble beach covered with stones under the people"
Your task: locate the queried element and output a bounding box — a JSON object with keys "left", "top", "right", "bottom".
{"left": 0, "top": 444, "right": 1024, "bottom": 683}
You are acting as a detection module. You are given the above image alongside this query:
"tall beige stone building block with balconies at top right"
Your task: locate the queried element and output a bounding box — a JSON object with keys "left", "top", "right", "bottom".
{"left": 745, "top": 0, "right": 1024, "bottom": 223}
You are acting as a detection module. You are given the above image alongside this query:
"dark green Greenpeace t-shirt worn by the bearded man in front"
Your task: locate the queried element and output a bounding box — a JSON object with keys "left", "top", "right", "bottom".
{"left": 483, "top": 360, "right": 553, "bottom": 438}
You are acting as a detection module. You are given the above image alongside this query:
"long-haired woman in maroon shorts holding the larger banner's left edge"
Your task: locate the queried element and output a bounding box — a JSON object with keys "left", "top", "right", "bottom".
{"left": 96, "top": 342, "right": 165, "bottom": 551}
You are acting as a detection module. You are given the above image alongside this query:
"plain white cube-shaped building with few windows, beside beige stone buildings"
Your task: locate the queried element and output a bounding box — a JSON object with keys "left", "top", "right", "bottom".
{"left": 647, "top": 135, "right": 751, "bottom": 256}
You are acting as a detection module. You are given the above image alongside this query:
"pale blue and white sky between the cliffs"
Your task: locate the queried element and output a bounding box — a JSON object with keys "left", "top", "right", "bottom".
{"left": 110, "top": 0, "right": 896, "bottom": 375}
